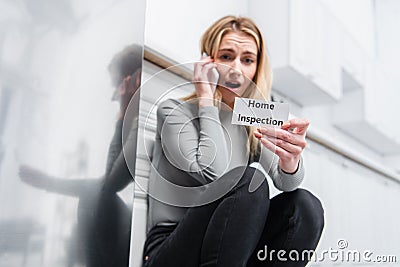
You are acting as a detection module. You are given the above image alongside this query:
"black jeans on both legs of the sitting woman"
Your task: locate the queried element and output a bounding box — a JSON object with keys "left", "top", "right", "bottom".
{"left": 144, "top": 167, "right": 324, "bottom": 267}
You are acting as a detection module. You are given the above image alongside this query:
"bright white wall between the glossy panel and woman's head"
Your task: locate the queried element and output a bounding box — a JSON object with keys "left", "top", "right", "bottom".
{"left": 145, "top": 0, "right": 247, "bottom": 63}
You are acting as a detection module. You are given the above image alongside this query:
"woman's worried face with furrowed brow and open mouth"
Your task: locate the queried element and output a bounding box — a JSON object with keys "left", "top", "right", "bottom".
{"left": 215, "top": 32, "right": 258, "bottom": 107}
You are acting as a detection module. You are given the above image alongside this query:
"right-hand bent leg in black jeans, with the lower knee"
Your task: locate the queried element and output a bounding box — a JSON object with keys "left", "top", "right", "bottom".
{"left": 248, "top": 189, "right": 324, "bottom": 267}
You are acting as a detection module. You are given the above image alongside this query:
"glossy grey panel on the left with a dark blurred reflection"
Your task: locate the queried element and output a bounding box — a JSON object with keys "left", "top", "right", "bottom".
{"left": 0, "top": 0, "right": 145, "bottom": 267}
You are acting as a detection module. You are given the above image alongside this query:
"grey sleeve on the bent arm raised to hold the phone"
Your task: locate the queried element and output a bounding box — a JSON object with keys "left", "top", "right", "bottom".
{"left": 157, "top": 99, "right": 228, "bottom": 184}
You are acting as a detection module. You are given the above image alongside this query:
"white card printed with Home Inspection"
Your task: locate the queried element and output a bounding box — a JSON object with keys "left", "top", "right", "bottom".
{"left": 232, "top": 97, "right": 289, "bottom": 127}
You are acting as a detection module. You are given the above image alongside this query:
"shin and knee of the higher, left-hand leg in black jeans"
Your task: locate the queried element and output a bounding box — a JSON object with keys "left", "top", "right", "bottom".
{"left": 199, "top": 168, "right": 269, "bottom": 267}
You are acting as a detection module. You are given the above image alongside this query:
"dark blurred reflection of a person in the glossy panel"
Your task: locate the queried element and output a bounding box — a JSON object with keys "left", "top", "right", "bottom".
{"left": 19, "top": 44, "right": 142, "bottom": 267}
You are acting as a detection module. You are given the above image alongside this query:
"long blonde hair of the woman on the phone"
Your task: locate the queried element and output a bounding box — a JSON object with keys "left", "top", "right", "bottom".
{"left": 183, "top": 16, "right": 272, "bottom": 160}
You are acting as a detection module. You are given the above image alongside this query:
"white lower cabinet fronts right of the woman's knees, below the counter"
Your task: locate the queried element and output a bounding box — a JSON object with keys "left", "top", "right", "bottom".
{"left": 302, "top": 142, "right": 400, "bottom": 266}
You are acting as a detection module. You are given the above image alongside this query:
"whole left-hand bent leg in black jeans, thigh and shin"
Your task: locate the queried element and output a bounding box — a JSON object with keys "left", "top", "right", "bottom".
{"left": 145, "top": 168, "right": 269, "bottom": 267}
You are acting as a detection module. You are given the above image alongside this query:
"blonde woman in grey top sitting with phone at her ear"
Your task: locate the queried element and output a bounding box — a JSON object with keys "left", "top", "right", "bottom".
{"left": 143, "top": 16, "right": 324, "bottom": 267}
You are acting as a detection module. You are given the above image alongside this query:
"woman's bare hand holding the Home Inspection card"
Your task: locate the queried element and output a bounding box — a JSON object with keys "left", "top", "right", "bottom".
{"left": 254, "top": 118, "right": 310, "bottom": 173}
